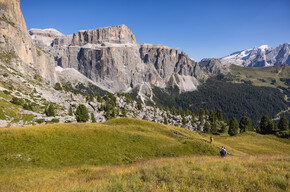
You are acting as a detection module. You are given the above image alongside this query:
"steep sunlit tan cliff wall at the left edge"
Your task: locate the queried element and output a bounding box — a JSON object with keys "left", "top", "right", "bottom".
{"left": 0, "top": 0, "right": 56, "bottom": 84}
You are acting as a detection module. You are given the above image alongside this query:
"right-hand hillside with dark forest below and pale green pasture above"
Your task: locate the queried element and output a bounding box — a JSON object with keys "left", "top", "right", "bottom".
{"left": 153, "top": 65, "right": 290, "bottom": 125}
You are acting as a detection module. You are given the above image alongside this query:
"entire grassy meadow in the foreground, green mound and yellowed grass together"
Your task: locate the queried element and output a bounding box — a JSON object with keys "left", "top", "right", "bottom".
{"left": 0, "top": 118, "right": 290, "bottom": 191}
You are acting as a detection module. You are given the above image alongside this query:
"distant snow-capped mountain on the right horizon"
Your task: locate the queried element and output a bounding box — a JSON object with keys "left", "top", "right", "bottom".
{"left": 220, "top": 43, "right": 290, "bottom": 67}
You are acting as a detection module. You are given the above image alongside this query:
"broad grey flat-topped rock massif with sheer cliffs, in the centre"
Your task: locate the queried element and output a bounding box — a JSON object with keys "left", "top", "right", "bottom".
{"left": 30, "top": 25, "right": 222, "bottom": 95}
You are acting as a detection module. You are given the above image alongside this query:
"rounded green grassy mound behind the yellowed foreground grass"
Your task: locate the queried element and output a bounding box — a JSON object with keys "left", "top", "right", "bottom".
{"left": 0, "top": 118, "right": 218, "bottom": 167}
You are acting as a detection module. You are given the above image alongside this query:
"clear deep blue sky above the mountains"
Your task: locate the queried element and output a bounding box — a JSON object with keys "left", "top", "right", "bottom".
{"left": 20, "top": 0, "right": 290, "bottom": 61}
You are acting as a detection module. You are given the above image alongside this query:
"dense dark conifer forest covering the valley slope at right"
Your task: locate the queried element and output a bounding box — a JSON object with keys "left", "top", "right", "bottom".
{"left": 153, "top": 78, "right": 288, "bottom": 126}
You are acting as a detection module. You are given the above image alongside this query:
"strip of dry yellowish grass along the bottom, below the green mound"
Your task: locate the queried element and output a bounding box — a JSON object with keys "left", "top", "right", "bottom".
{"left": 0, "top": 155, "right": 290, "bottom": 191}
